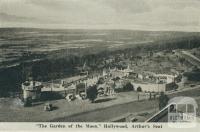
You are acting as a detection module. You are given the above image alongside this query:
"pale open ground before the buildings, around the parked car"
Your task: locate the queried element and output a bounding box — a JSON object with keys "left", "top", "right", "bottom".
{"left": 0, "top": 92, "right": 148, "bottom": 121}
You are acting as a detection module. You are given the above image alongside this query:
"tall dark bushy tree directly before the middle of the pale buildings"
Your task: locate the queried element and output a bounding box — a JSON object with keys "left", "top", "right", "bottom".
{"left": 87, "top": 85, "right": 98, "bottom": 103}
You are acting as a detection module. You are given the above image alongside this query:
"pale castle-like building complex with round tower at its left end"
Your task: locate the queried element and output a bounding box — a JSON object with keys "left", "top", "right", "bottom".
{"left": 22, "top": 66, "right": 177, "bottom": 102}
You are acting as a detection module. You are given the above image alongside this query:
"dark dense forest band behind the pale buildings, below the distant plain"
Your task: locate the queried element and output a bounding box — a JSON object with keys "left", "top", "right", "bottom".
{"left": 0, "top": 37, "right": 200, "bottom": 97}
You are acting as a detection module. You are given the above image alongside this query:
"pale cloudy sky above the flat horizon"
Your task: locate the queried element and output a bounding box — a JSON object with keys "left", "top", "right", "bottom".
{"left": 0, "top": 0, "right": 200, "bottom": 32}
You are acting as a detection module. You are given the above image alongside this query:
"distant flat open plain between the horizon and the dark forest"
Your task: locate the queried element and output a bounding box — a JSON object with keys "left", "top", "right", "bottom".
{"left": 0, "top": 28, "right": 200, "bottom": 67}
